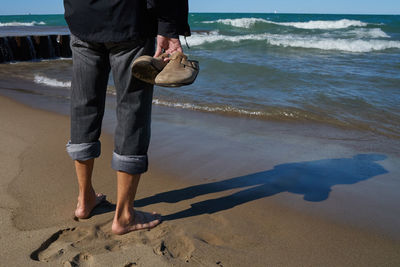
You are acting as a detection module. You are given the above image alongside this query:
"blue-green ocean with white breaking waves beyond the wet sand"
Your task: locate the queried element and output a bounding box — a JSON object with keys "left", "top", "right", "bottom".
{"left": 0, "top": 13, "right": 400, "bottom": 139}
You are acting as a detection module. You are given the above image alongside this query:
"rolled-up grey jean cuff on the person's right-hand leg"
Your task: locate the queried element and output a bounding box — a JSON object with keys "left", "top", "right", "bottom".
{"left": 111, "top": 152, "right": 148, "bottom": 174}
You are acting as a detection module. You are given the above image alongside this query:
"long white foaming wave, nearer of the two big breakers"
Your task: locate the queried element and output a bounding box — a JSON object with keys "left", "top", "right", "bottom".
{"left": 184, "top": 32, "right": 400, "bottom": 52}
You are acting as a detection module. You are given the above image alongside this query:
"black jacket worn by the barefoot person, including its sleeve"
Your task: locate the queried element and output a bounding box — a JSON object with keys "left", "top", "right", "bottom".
{"left": 64, "top": 0, "right": 190, "bottom": 42}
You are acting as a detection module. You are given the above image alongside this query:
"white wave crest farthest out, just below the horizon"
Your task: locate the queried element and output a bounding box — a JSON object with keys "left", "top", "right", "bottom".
{"left": 203, "top": 18, "right": 368, "bottom": 30}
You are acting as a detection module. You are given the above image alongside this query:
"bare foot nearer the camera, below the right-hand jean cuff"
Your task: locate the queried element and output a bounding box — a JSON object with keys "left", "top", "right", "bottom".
{"left": 111, "top": 210, "right": 161, "bottom": 235}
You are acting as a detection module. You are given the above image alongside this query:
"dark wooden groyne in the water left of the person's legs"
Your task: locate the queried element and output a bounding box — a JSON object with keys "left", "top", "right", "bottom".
{"left": 0, "top": 35, "right": 72, "bottom": 63}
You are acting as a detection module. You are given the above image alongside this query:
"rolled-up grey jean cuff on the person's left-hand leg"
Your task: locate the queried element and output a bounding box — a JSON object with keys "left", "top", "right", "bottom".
{"left": 67, "top": 141, "right": 101, "bottom": 161}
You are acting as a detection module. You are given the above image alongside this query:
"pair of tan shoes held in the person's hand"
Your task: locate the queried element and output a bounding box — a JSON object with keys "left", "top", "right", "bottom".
{"left": 132, "top": 52, "right": 200, "bottom": 87}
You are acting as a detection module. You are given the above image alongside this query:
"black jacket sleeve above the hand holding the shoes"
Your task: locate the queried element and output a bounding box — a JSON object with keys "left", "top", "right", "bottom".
{"left": 152, "top": 0, "right": 191, "bottom": 38}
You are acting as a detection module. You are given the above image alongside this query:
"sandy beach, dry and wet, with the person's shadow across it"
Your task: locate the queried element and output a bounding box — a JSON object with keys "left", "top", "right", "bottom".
{"left": 0, "top": 83, "right": 400, "bottom": 266}
